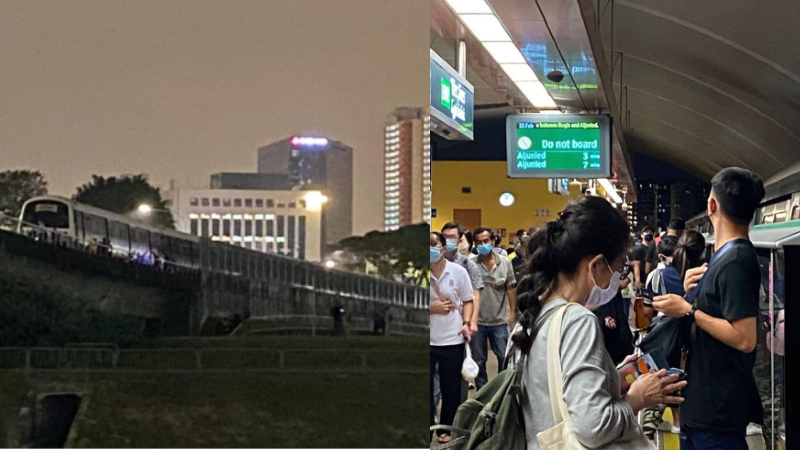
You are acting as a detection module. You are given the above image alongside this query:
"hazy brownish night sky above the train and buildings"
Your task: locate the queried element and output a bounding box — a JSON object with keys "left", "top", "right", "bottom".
{"left": 0, "top": 0, "right": 429, "bottom": 233}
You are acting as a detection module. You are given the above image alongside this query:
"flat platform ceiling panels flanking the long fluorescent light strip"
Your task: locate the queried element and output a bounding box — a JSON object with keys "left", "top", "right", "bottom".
{"left": 431, "top": 0, "right": 636, "bottom": 201}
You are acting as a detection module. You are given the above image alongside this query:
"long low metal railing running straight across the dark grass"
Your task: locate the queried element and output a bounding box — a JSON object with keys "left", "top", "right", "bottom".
{"left": 0, "top": 348, "right": 430, "bottom": 373}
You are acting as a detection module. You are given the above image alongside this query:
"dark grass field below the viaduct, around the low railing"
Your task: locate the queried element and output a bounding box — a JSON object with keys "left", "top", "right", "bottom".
{"left": 0, "top": 337, "right": 429, "bottom": 448}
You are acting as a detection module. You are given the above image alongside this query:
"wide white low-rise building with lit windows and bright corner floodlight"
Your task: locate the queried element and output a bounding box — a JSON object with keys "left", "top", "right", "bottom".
{"left": 171, "top": 189, "right": 325, "bottom": 262}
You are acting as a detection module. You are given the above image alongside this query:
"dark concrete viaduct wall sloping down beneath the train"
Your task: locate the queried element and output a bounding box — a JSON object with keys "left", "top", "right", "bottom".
{"left": 0, "top": 231, "right": 429, "bottom": 335}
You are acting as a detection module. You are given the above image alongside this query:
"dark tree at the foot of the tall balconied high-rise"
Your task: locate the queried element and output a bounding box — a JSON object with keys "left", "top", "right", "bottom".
{"left": 338, "top": 223, "right": 430, "bottom": 284}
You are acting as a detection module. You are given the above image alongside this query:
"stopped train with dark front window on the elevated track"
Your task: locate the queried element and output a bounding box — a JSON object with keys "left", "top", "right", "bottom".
{"left": 17, "top": 196, "right": 200, "bottom": 268}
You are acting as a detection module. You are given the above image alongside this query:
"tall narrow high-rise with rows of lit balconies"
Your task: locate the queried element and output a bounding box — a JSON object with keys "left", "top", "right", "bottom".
{"left": 384, "top": 108, "right": 431, "bottom": 231}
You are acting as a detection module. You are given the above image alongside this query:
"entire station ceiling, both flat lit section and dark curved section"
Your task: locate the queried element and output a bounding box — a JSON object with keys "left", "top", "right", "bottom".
{"left": 431, "top": 0, "right": 800, "bottom": 197}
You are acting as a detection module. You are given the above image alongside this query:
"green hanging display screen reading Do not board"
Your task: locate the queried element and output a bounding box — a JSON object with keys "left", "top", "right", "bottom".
{"left": 506, "top": 114, "right": 611, "bottom": 178}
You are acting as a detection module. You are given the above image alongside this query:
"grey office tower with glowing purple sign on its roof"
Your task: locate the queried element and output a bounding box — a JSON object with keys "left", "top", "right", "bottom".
{"left": 258, "top": 136, "right": 353, "bottom": 253}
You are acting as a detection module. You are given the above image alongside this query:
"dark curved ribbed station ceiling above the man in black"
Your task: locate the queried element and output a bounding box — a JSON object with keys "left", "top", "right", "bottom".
{"left": 600, "top": 0, "right": 800, "bottom": 180}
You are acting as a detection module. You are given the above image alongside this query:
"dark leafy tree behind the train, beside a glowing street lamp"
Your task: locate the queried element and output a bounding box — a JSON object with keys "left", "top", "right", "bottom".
{"left": 73, "top": 174, "right": 175, "bottom": 229}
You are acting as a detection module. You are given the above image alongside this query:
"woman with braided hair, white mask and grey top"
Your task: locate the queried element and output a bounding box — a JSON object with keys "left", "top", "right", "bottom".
{"left": 509, "top": 196, "right": 685, "bottom": 450}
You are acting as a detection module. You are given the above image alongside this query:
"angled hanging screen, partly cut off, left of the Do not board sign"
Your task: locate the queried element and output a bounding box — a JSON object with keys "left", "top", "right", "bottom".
{"left": 431, "top": 50, "right": 475, "bottom": 140}
